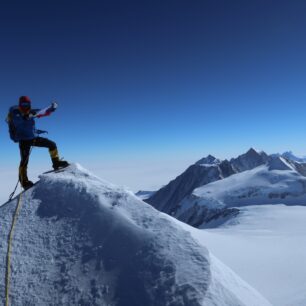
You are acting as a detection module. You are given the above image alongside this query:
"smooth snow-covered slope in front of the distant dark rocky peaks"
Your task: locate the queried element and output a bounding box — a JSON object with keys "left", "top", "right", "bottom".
{"left": 193, "top": 165, "right": 306, "bottom": 207}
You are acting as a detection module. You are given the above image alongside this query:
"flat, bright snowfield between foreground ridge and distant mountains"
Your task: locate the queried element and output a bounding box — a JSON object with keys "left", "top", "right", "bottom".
{"left": 186, "top": 205, "right": 306, "bottom": 306}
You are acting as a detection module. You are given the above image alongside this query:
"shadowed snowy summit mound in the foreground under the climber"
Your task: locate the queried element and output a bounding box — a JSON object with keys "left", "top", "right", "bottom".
{"left": 0, "top": 165, "right": 270, "bottom": 306}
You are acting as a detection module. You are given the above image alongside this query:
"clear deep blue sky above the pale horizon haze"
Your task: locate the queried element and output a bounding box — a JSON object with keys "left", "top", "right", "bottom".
{"left": 0, "top": 0, "right": 306, "bottom": 194}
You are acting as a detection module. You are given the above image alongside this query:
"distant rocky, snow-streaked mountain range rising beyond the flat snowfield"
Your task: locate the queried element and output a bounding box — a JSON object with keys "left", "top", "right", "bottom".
{"left": 145, "top": 148, "right": 306, "bottom": 228}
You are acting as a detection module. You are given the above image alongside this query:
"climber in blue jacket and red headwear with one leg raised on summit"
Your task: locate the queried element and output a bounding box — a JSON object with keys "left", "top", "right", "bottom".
{"left": 6, "top": 96, "right": 69, "bottom": 189}
